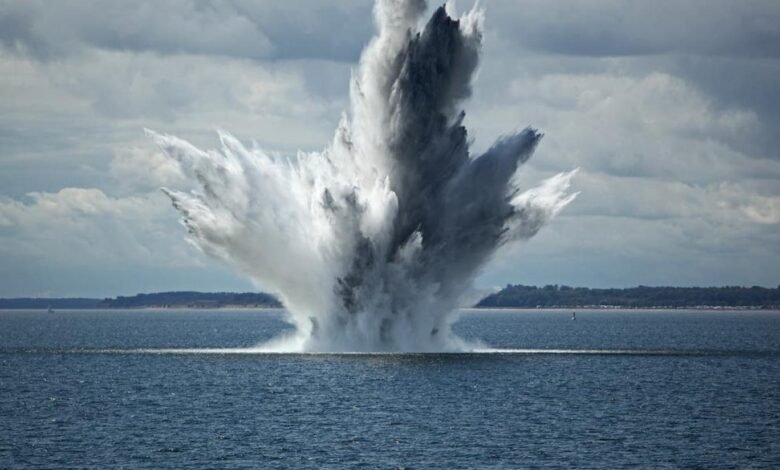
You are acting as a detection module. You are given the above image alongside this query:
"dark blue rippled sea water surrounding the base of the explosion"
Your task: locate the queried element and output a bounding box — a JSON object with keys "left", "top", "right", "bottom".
{"left": 0, "top": 310, "right": 780, "bottom": 469}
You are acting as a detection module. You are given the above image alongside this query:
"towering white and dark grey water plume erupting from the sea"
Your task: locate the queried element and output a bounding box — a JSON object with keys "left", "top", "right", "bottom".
{"left": 150, "top": 0, "right": 576, "bottom": 351}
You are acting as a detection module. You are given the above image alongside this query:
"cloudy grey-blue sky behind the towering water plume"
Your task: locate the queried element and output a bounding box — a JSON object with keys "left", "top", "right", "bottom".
{"left": 0, "top": 0, "right": 780, "bottom": 297}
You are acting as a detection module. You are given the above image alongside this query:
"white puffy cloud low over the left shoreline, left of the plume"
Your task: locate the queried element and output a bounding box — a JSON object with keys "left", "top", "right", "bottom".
{"left": 0, "top": 188, "right": 193, "bottom": 268}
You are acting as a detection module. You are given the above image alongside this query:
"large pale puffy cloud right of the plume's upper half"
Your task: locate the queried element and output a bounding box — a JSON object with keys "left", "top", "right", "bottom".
{"left": 500, "top": 73, "right": 768, "bottom": 182}
